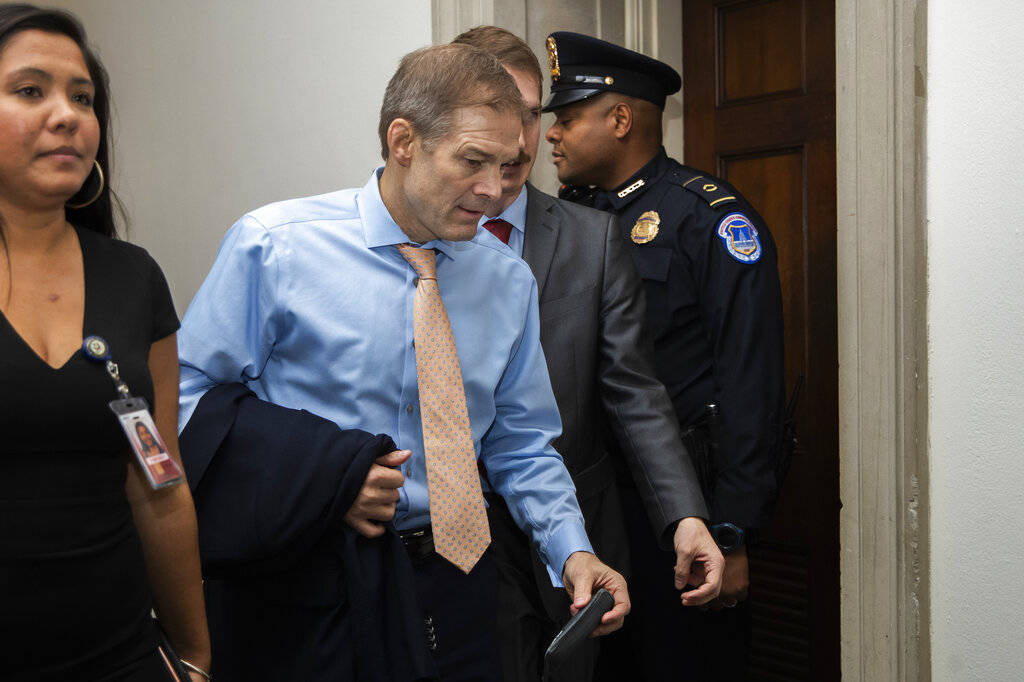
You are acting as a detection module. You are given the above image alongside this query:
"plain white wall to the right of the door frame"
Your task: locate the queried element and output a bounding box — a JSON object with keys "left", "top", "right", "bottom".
{"left": 927, "top": 0, "right": 1024, "bottom": 682}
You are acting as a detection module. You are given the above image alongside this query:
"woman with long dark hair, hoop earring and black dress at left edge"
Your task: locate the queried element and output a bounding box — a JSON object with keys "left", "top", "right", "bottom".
{"left": 0, "top": 4, "right": 210, "bottom": 682}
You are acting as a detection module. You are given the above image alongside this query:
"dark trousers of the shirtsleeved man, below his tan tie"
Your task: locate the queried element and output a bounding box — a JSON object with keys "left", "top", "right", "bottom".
{"left": 412, "top": 549, "right": 502, "bottom": 682}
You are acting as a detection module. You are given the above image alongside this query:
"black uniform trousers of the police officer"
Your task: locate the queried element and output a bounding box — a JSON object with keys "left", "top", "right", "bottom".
{"left": 595, "top": 483, "right": 751, "bottom": 682}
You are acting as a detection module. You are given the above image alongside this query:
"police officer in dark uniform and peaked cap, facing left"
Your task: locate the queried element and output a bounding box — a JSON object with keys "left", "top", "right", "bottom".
{"left": 544, "top": 32, "right": 784, "bottom": 682}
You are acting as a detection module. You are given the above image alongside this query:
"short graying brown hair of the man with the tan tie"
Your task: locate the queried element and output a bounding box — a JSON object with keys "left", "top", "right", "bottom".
{"left": 378, "top": 44, "right": 524, "bottom": 161}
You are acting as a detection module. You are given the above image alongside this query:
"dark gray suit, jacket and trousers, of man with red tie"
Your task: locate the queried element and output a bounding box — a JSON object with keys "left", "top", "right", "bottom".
{"left": 488, "top": 184, "right": 708, "bottom": 682}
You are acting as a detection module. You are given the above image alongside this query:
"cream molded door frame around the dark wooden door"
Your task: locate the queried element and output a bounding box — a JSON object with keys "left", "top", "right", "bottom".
{"left": 432, "top": 0, "right": 931, "bottom": 681}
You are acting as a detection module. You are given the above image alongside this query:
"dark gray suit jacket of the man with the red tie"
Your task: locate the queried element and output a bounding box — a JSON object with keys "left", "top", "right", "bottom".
{"left": 523, "top": 184, "right": 708, "bottom": 560}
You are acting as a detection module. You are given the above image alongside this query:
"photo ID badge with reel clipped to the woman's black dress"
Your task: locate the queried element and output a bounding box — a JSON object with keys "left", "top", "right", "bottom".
{"left": 82, "top": 336, "right": 184, "bottom": 489}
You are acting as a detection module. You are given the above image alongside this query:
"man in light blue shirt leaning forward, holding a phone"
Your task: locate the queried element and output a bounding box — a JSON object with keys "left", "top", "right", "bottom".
{"left": 178, "top": 46, "right": 629, "bottom": 680}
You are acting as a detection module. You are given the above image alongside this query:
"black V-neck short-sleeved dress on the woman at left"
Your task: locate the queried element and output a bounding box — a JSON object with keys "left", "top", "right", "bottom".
{"left": 0, "top": 229, "right": 178, "bottom": 682}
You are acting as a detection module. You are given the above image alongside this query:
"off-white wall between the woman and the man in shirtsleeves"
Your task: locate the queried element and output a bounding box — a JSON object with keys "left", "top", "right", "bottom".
{"left": 47, "top": 0, "right": 430, "bottom": 314}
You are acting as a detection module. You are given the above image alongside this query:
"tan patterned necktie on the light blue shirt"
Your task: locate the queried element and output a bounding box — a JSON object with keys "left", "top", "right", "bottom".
{"left": 398, "top": 244, "right": 490, "bottom": 573}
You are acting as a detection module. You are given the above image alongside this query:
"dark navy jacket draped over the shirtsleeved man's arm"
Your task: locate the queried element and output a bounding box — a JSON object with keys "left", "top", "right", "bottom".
{"left": 180, "top": 383, "right": 437, "bottom": 682}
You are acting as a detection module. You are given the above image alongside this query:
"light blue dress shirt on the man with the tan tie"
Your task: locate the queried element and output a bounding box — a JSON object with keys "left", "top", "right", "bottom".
{"left": 178, "top": 171, "right": 593, "bottom": 586}
